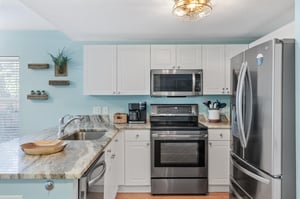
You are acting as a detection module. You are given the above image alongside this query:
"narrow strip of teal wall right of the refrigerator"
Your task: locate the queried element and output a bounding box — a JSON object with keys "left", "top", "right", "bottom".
{"left": 295, "top": 0, "right": 300, "bottom": 199}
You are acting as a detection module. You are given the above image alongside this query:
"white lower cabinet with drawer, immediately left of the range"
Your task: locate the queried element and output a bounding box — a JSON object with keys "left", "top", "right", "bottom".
{"left": 123, "top": 130, "right": 150, "bottom": 186}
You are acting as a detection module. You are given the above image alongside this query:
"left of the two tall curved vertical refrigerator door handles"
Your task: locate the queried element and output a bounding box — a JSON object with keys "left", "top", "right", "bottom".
{"left": 236, "top": 62, "right": 246, "bottom": 148}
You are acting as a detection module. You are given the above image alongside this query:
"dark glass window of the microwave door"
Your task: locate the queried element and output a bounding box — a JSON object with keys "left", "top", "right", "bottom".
{"left": 153, "top": 74, "right": 193, "bottom": 92}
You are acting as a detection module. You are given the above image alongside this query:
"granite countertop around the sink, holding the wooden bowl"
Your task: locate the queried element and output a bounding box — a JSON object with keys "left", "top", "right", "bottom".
{"left": 0, "top": 116, "right": 118, "bottom": 179}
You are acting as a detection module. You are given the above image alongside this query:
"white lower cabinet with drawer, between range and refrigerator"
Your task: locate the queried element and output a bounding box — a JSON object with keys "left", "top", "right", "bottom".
{"left": 208, "top": 129, "right": 230, "bottom": 192}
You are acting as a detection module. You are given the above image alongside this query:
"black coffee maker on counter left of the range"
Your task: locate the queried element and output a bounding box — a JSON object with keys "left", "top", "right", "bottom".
{"left": 128, "top": 102, "right": 147, "bottom": 124}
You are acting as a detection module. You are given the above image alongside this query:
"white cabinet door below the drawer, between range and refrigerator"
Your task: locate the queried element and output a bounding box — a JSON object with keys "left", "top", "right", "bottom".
{"left": 208, "top": 140, "right": 230, "bottom": 185}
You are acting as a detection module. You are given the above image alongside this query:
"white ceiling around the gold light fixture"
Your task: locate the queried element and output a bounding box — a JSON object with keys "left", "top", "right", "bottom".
{"left": 0, "top": 0, "right": 295, "bottom": 42}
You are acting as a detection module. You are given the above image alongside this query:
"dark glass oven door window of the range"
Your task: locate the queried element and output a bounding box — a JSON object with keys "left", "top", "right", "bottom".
{"left": 154, "top": 140, "right": 205, "bottom": 167}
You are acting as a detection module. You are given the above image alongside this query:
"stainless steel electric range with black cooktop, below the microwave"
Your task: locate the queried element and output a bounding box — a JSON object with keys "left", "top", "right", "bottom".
{"left": 150, "top": 104, "right": 208, "bottom": 194}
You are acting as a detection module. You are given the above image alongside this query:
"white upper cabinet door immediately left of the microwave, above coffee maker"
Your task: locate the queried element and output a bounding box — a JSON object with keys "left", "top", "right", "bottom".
{"left": 117, "top": 45, "right": 150, "bottom": 95}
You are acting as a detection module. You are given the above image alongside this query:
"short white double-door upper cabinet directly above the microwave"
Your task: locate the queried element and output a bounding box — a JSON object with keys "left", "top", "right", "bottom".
{"left": 151, "top": 45, "right": 201, "bottom": 69}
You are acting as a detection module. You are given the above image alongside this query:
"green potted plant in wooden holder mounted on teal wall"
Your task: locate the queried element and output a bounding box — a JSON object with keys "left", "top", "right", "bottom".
{"left": 49, "top": 48, "right": 71, "bottom": 76}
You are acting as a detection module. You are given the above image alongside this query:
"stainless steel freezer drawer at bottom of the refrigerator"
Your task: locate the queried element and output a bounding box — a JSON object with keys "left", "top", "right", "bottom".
{"left": 230, "top": 158, "right": 281, "bottom": 199}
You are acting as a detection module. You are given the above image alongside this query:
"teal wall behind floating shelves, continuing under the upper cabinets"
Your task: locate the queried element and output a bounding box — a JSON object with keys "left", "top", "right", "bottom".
{"left": 0, "top": 31, "right": 230, "bottom": 134}
